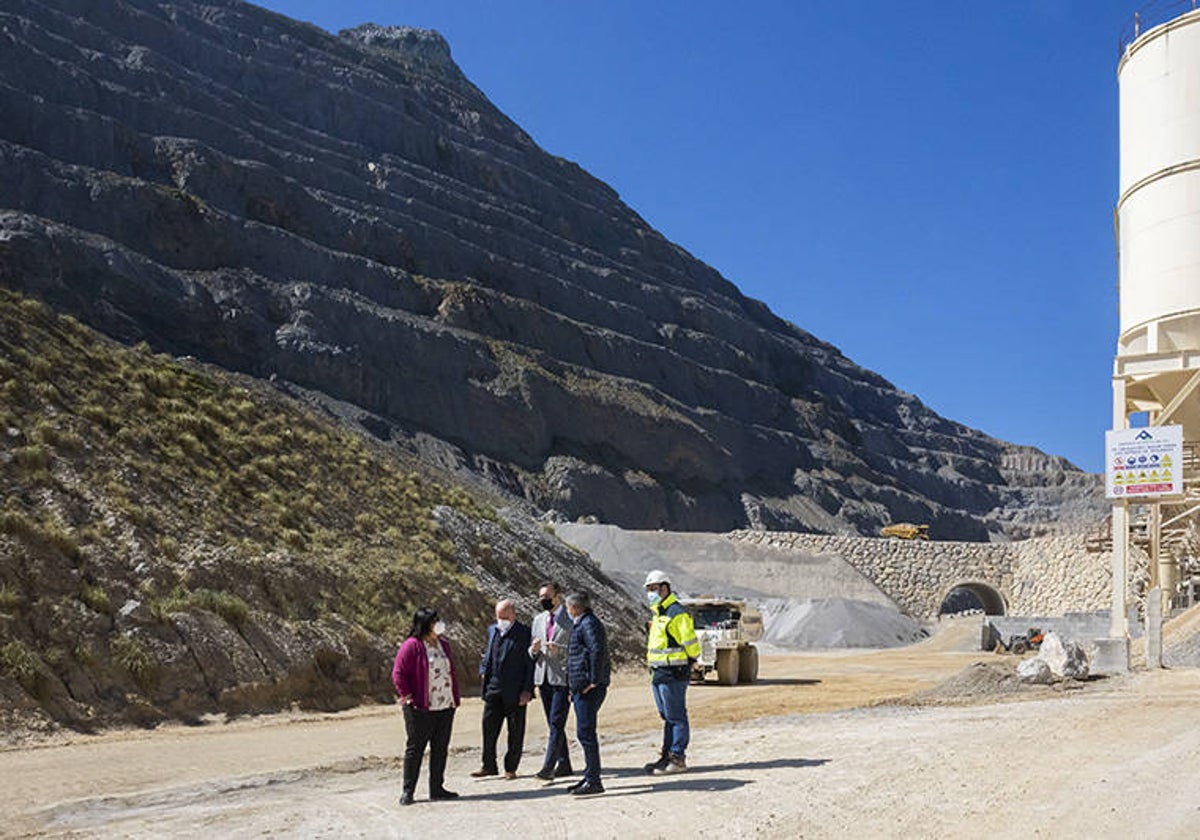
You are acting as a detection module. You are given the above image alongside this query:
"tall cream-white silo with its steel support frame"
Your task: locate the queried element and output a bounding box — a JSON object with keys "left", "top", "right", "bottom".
{"left": 1112, "top": 8, "right": 1200, "bottom": 657}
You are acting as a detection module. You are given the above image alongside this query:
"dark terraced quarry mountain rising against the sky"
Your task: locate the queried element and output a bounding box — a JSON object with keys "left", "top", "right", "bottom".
{"left": 0, "top": 0, "right": 1102, "bottom": 540}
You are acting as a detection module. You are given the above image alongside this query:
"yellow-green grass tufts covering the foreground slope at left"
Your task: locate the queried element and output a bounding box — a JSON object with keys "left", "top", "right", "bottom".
{"left": 0, "top": 289, "right": 508, "bottom": 729}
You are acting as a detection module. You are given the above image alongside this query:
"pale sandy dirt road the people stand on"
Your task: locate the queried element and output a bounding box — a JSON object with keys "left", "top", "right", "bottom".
{"left": 0, "top": 628, "right": 1200, "bottom": 838}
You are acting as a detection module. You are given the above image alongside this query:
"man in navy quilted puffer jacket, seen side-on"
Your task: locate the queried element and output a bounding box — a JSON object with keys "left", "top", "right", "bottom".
{"left": 566, "top": 592, "right": 612, "bottom": 796}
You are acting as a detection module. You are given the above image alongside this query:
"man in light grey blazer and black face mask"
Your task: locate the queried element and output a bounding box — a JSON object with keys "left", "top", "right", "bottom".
{"left": 529, "top": 583, "right": 575, "bottom": 781}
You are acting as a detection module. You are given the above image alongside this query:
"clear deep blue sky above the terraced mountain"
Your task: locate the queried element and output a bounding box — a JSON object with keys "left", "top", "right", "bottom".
{"left": 259, "top": 0, "right": 1145, "bottom": 472}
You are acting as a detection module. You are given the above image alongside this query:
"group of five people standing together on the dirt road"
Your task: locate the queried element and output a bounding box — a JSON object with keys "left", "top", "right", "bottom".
{"left": 391, "top": 570, "right": 700, "bottom": 805}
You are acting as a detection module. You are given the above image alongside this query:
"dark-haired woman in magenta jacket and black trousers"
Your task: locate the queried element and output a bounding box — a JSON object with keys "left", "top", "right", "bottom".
{"left": 391, "top": 607, "right": 458, "bottom": 805}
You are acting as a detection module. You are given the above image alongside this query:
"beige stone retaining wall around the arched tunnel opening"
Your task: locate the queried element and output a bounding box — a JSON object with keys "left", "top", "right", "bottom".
{"left": 728, "top": 530, "right": 1112, "bottom": 618}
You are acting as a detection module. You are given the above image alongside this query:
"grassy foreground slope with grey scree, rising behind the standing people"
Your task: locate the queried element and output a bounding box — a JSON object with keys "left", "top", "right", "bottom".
{"left": 0, "top": 290, "right": 643, "bottom": 730}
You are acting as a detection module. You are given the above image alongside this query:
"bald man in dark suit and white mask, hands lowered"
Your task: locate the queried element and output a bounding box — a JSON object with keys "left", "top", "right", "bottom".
{"left": 472, "top": 599, "right": 533, "bottom": 779}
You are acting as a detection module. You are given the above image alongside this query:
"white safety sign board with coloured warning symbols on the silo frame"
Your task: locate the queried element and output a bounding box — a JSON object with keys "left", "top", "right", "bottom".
{"left": 1104, "top": 426, "right": 1183, "bottom": 500}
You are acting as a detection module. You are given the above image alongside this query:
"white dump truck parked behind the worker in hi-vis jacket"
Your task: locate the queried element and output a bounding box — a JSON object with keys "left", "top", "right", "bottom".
{"left": 679, "top": 598, "right": 762, "bottom": 685}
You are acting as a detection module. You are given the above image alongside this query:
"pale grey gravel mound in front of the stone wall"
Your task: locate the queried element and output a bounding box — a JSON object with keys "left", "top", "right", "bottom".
{"left": 756, "top": 598, "right": 929, "bottom": 650}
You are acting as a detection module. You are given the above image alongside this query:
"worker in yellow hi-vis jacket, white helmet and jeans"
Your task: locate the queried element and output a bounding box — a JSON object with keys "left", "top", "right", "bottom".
{"left": 646, "top": 569, "right": 700, "bottom": 775}
